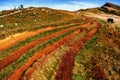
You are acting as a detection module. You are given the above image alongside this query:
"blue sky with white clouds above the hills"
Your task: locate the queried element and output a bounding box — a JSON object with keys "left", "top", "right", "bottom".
{"left": 0, "top": 0, "right": 120, "bottom": 11}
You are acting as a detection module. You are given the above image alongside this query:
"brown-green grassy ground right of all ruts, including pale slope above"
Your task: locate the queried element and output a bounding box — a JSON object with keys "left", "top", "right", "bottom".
{"left": 73, "top": 3, "right": 120, "bottom": 80}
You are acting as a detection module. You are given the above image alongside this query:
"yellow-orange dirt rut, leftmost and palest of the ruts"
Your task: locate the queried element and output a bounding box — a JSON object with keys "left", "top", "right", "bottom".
{"left": 0, "top": 16, "right": 87, "bottom": 51}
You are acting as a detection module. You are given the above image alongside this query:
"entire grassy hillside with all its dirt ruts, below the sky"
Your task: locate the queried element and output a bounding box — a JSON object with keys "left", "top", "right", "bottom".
{"left": 0, "top": 4, "right": 120, "bottom": 80}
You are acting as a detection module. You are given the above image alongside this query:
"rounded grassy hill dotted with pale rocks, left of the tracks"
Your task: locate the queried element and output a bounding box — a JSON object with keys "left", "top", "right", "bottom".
{"left": 0, "top": 8, "right": 73, "bottom": 38}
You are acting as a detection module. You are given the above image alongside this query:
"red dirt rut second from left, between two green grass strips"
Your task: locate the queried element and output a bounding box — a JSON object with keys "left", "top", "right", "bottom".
{"left": 0, "top": 23, "right": 89, "bottom": 70}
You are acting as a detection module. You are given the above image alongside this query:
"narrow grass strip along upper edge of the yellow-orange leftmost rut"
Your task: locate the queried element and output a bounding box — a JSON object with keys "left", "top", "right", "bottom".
{"left": 0, "top": 18, "right": 82, "bottom": 39}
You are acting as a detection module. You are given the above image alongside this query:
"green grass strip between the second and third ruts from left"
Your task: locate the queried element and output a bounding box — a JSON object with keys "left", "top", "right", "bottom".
{"left": 0, "top": 29, "right": 77, "bottom": 79}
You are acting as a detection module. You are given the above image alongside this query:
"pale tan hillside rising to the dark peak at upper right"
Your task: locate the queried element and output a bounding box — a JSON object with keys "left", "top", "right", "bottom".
{"left": 77, "top": 2, "right": 120, "bottom": 27}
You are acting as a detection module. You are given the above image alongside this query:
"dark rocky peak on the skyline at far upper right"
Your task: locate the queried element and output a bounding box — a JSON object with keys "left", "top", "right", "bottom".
{"left": 100, "top": 2, "right": 120, "bottom": 16}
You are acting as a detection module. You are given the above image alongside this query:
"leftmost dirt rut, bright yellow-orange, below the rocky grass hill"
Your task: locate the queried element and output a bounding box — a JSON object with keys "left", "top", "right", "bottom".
{"left": 0, "top": 23, "right": 83, "bottom": 51}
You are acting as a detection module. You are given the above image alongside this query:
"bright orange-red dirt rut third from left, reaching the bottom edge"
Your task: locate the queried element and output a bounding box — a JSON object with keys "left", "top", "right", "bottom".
{"left": 9, "top": 17, "right": 94, "bottom": 80}
